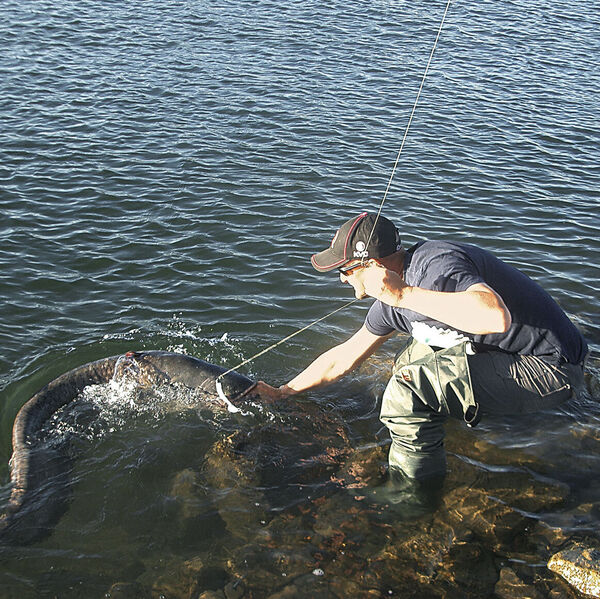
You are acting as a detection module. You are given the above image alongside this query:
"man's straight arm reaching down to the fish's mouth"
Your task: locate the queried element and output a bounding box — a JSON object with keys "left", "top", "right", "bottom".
{"left": 254, "top": 325, "right": 394, "bottom": 399}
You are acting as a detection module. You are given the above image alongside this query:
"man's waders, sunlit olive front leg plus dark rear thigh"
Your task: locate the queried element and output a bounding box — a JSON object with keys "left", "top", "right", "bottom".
{"left": 380, "top": 338, "right": 583, "bottom": 478}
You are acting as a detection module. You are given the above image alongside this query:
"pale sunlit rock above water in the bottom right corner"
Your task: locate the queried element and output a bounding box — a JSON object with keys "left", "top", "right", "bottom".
{"left": 548, "top": 543, "right": 600, "bottom": 597}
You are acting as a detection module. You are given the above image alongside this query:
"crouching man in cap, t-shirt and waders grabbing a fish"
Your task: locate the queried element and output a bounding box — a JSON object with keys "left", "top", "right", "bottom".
{"left": 258, "top": 212, "right": 587, "bottom": 480}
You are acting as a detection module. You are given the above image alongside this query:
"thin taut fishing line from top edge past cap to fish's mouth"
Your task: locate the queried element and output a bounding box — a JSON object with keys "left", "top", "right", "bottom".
{"left": 215, "top": 0, "right": 452, "bottom": 410}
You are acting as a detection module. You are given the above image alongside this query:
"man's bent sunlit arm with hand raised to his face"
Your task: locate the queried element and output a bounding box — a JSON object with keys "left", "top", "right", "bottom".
{"left": 358, "top": 265, "right": 511, "bottom": 335}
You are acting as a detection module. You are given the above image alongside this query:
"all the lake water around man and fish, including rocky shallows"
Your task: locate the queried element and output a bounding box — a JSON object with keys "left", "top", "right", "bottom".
{"left": 0, "top": 0, "right": 600, "bottom": 598}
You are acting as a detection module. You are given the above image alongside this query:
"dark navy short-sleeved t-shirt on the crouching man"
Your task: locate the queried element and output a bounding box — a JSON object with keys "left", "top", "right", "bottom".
{"left": 365, "top": 241, "right": 587, "bottom": 364}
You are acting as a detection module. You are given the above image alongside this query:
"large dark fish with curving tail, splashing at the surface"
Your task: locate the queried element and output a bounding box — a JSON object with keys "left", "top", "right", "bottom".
{"left": 0, "top": 351, "right": 256, "bottom": 544}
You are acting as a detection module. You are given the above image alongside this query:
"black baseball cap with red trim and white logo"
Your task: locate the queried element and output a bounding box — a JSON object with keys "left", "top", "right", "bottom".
{"left": 310, "top": 212, "right": 401, "bottom": 272}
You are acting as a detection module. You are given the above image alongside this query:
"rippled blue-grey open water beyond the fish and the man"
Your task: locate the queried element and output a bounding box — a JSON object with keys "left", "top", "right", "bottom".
{"left": 0, "top": 0, "right": 600, "bottom": 594}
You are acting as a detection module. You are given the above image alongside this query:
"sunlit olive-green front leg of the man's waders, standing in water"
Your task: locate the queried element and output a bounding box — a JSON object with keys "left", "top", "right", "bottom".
{"left": 380, "top": 338, "right": 479, "bottom": 478}
